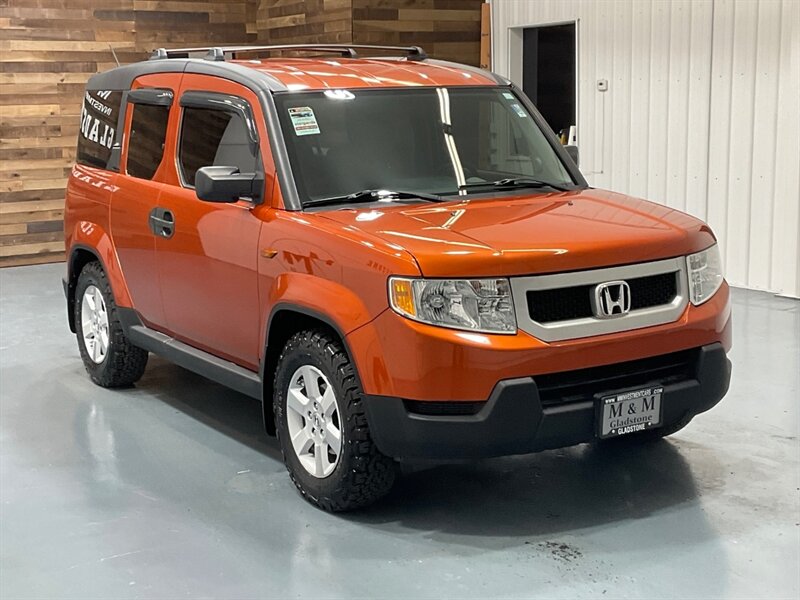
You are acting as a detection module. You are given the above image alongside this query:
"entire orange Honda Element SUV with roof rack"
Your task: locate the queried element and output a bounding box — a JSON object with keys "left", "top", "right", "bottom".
{"left": 64, "top": 45, "right": 731, "bottom": 511}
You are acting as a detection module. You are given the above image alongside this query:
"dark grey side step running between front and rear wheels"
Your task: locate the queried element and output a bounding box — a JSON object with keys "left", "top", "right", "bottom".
{"left": 126, "top": 324, "right": 264, "bottom": 400}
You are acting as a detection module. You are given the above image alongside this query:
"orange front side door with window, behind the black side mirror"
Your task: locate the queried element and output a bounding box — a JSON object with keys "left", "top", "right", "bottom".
{"left": 156, "top": 74, "right": 271, "bottom": 370}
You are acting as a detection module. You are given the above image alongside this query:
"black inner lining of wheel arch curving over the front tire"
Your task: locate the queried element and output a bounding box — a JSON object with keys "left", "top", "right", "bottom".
{"left": 261, "top": 302, "right": 361, "bottom": 436}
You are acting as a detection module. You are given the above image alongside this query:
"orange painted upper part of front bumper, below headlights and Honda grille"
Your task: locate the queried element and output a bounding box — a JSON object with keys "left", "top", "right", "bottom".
{"left": 346, "top": 283, "right": 731, "bottom": 402}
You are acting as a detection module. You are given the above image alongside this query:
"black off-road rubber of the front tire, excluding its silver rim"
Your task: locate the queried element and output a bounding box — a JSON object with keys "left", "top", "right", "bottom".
{"left": 273, "top": 330, "right": 397, "bottom": 512}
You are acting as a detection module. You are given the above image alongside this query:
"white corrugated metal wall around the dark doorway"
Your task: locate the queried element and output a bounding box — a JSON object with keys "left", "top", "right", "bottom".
{"left": 492, "top": 0, "right": 800, "bottom": 296}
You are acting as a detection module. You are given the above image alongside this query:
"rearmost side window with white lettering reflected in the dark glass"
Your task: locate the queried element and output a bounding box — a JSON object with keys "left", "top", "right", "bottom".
{"left": 75, "top": 90, "right": 122, "bottom": 169}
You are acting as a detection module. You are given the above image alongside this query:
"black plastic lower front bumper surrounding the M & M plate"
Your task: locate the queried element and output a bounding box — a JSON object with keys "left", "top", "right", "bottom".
{"left": 364, "top": 343, "right": 731, "bottom": 460}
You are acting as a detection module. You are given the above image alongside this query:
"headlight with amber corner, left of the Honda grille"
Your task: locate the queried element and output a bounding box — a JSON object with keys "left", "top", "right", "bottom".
{"left": 389, "top": 277, "right": 517, "bottom": 333}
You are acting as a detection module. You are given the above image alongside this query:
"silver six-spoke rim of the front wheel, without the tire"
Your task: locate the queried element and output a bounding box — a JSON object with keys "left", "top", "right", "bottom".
{"left": 286, "top": 365, "right": 342, "bottom": 479}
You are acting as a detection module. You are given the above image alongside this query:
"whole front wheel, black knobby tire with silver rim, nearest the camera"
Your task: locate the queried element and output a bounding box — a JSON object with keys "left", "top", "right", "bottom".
{"left": 273, "top": 330, "right": 397, "bottom": 512}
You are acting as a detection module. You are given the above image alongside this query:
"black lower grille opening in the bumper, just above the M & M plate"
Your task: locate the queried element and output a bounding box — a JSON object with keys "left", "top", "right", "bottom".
{"left": 533, "top": 348, "right": 699, "bottom": 406}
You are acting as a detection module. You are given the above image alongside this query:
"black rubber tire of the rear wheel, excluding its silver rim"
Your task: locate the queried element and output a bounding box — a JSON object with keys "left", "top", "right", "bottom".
{"left": 74, "top": 261, "right": 148, "bottom": 388}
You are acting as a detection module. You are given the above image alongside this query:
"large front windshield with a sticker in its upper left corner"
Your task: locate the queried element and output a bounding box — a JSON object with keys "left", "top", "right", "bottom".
{"left": 275, "top": 87, "right": 573, "bottom": 202}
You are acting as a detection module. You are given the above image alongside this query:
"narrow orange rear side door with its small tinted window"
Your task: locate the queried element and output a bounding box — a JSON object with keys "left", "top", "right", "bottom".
{"left": 109, "top": 74, "right": 181, "bottom": 330}
